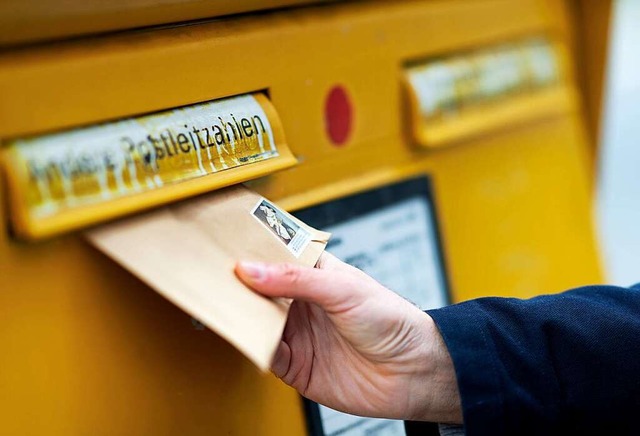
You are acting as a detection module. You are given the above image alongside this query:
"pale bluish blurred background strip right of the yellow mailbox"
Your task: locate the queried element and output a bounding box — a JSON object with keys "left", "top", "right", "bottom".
{"left": 597, "top": 0, "right": 640, "bottom": 285}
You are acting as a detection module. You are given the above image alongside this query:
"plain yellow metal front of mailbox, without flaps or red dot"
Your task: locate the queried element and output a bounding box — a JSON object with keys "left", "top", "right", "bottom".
{"left": 0, "top": 0, "right": 601, "bottom": 436}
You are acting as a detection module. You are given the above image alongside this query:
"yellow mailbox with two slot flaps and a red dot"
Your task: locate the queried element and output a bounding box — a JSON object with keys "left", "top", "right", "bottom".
{"left": 0, "top": 0, "right": 601, "bottom": 436}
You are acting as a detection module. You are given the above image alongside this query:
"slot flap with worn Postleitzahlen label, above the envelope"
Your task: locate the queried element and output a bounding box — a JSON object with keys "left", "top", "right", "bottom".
{"left": 3, "top": 92, "right": 296, "bottom": 239}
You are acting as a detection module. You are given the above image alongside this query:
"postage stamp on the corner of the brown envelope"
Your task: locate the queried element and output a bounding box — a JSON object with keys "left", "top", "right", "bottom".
{"left": 251, "top": 198, "right": 311, "bottom": 257}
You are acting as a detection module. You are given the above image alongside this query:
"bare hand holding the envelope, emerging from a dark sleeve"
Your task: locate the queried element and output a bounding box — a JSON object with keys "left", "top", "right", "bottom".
{"left": 235, "top": 253, "right": 462, "bottom": 423}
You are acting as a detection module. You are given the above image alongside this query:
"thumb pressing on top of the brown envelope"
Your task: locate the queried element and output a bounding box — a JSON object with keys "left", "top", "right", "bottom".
{"left": 235, "top": 261, "right": 363, "bottom": 313}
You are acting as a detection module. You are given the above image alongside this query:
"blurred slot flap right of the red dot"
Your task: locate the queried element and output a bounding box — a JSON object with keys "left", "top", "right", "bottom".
{"left": 404, "top": 36, "right": 572, "bottom": 147}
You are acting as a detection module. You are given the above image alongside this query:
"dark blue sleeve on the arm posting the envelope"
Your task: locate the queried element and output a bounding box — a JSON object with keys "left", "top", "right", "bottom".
{"left": 427, "top": 285, "right": 640, "bottom": 436}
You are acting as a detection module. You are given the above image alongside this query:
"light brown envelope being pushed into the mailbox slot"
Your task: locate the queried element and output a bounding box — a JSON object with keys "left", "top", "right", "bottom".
{"left": 87, "top": 186, "right": 330, "bottom": 371}
